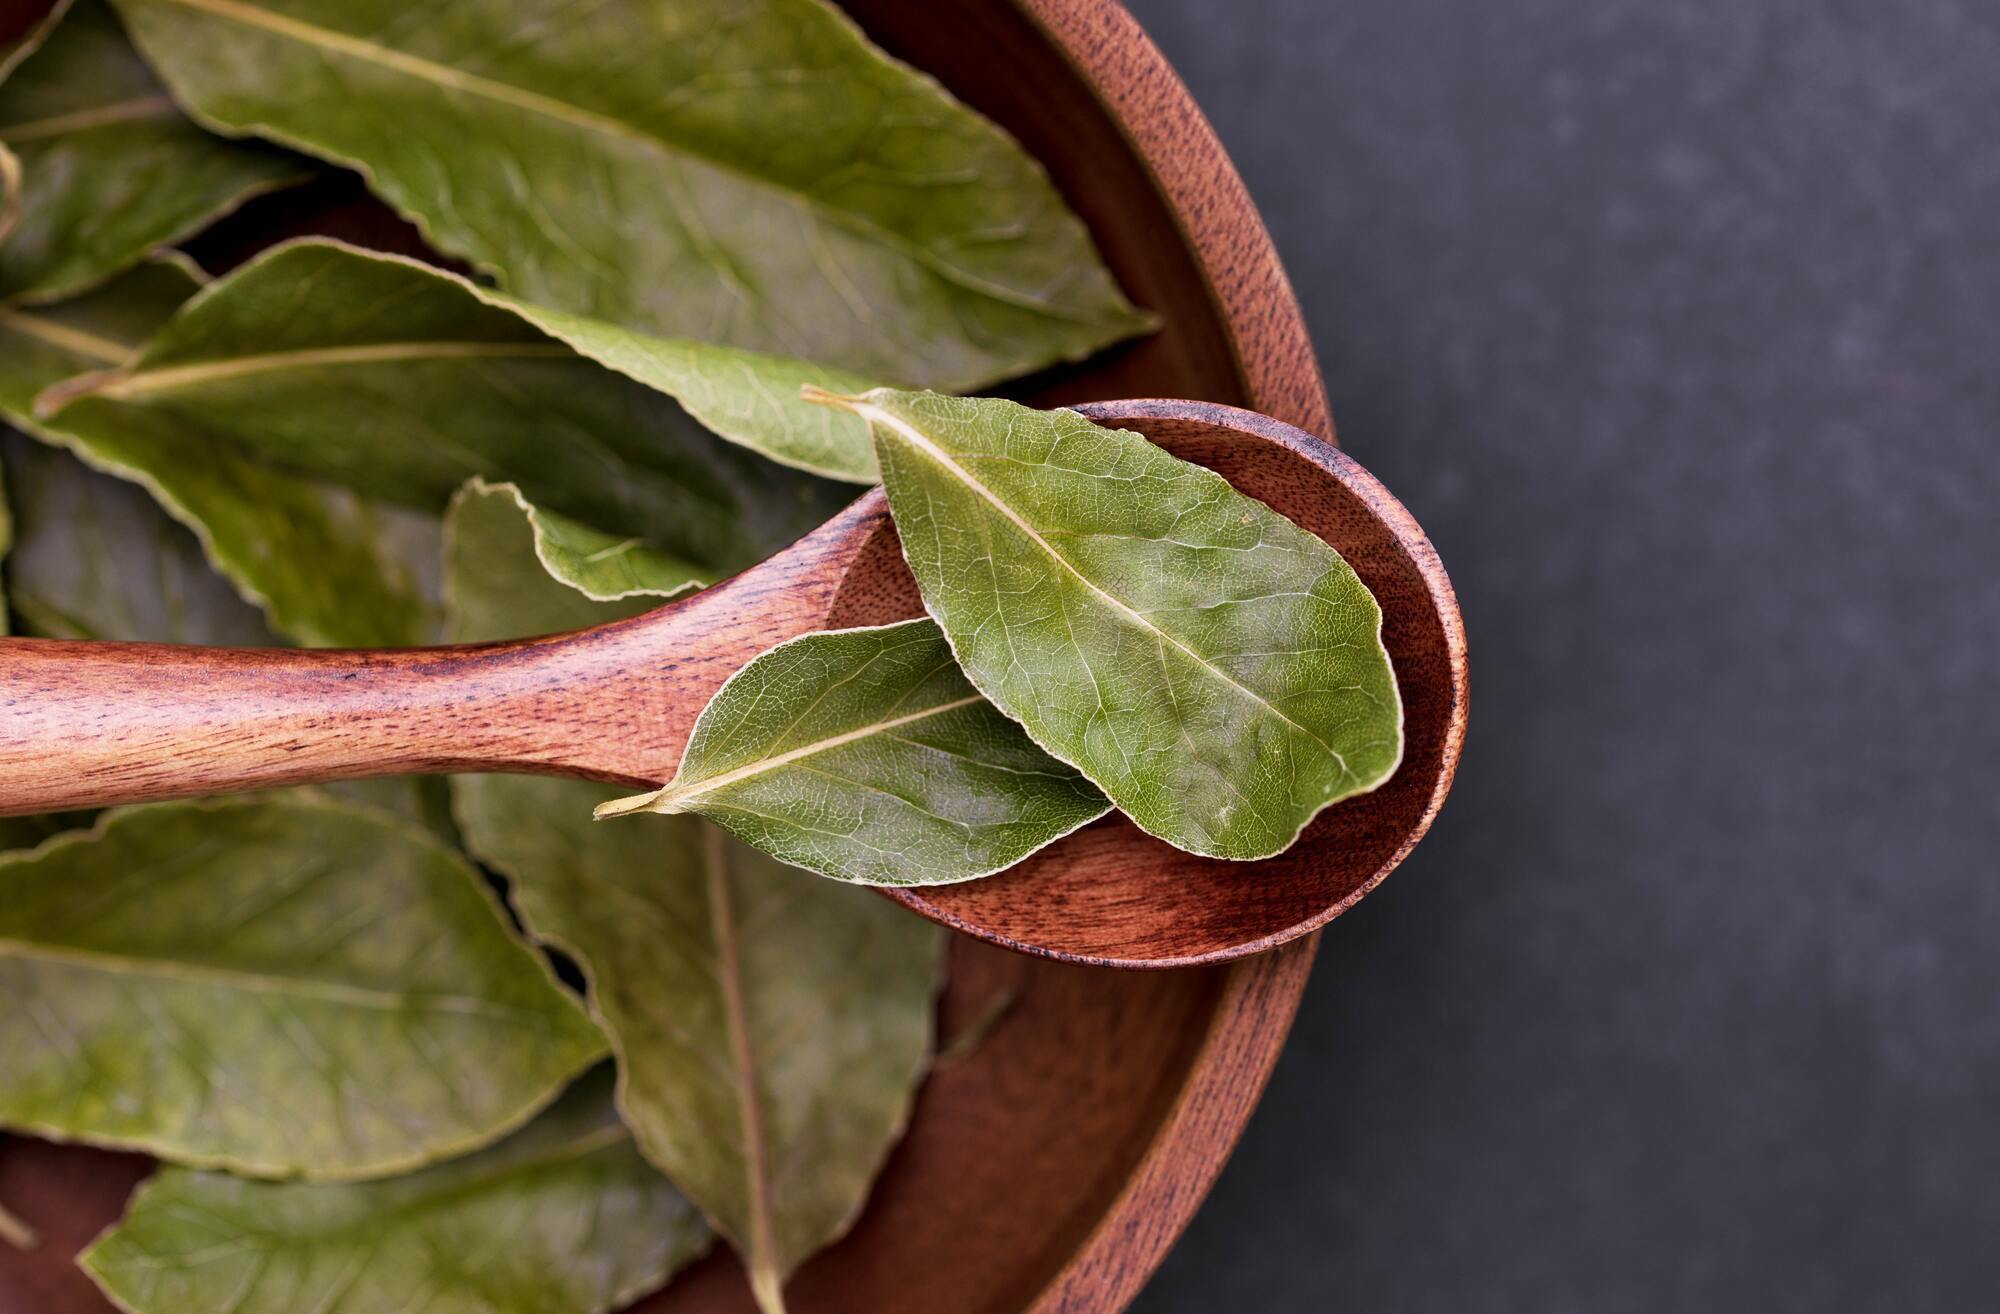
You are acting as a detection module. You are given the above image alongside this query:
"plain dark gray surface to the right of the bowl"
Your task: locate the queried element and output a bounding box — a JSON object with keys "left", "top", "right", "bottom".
{"left": 1130, "top": 0, "right": 2000, "bottom": 1314}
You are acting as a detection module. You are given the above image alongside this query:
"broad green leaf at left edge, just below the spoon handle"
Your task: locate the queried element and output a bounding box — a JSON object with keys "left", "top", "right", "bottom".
{"left": 0, "top": 796, "right": 604, "bottom": 1178}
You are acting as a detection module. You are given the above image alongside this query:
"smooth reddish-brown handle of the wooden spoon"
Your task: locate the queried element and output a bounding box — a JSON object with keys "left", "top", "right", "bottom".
{"left": 0, "top": 498, "right": 882, "bottom": 816}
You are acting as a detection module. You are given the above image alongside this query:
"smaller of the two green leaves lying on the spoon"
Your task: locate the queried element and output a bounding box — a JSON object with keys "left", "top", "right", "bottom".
{"left": 598, "top": 620, "right": 1110, "bottom": 886}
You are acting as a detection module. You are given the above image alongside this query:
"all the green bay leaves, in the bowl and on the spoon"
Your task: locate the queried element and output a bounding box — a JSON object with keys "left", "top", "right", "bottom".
{"left": 0, "top": 0, "right": 1400, "bottom": 1314}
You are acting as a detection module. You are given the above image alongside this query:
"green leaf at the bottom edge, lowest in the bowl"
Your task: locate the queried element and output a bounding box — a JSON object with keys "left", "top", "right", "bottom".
{"left": 80, "top": 1070, "right": 712, "bottom": 1314}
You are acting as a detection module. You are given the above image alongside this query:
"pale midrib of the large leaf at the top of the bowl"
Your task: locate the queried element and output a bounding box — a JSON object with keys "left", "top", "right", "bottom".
{"left": 150, "top": 0, "right": 1092, "bottom": 322}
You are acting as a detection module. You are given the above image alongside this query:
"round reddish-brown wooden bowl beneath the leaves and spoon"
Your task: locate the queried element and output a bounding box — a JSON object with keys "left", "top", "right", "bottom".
{"left": 0, "top": 0, "right": 1464, "bottom": 1314}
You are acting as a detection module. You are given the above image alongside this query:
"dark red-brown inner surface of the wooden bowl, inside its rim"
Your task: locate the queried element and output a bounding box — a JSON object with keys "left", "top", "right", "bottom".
{"left": 0, "top": 0, "right": 1316, "bottom": 1314}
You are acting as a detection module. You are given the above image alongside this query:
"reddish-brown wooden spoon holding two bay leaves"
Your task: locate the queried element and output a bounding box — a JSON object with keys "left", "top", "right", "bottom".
{"left": 0, "top": 402, "right": 1466, "bottom": 968}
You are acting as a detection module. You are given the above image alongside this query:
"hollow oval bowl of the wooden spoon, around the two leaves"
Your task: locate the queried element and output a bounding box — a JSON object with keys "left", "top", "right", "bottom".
{"left": 860, "top": 400, "right": 1466, "bottom": 968}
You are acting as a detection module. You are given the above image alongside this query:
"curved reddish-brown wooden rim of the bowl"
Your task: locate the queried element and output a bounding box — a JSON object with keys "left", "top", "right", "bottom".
{"left": 1012, "top": 0, "right": 1338, "bottom": 1314}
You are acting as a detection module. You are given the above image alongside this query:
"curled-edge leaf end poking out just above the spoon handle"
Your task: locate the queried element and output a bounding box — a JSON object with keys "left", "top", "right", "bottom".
{"left": 444, "top": 480, "right": 702, "bottom": 644}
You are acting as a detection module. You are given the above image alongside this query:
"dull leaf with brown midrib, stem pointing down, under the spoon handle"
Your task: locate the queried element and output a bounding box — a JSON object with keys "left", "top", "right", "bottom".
{"left": 446, "top": 506, "right": 942, "bottom": 1310}
